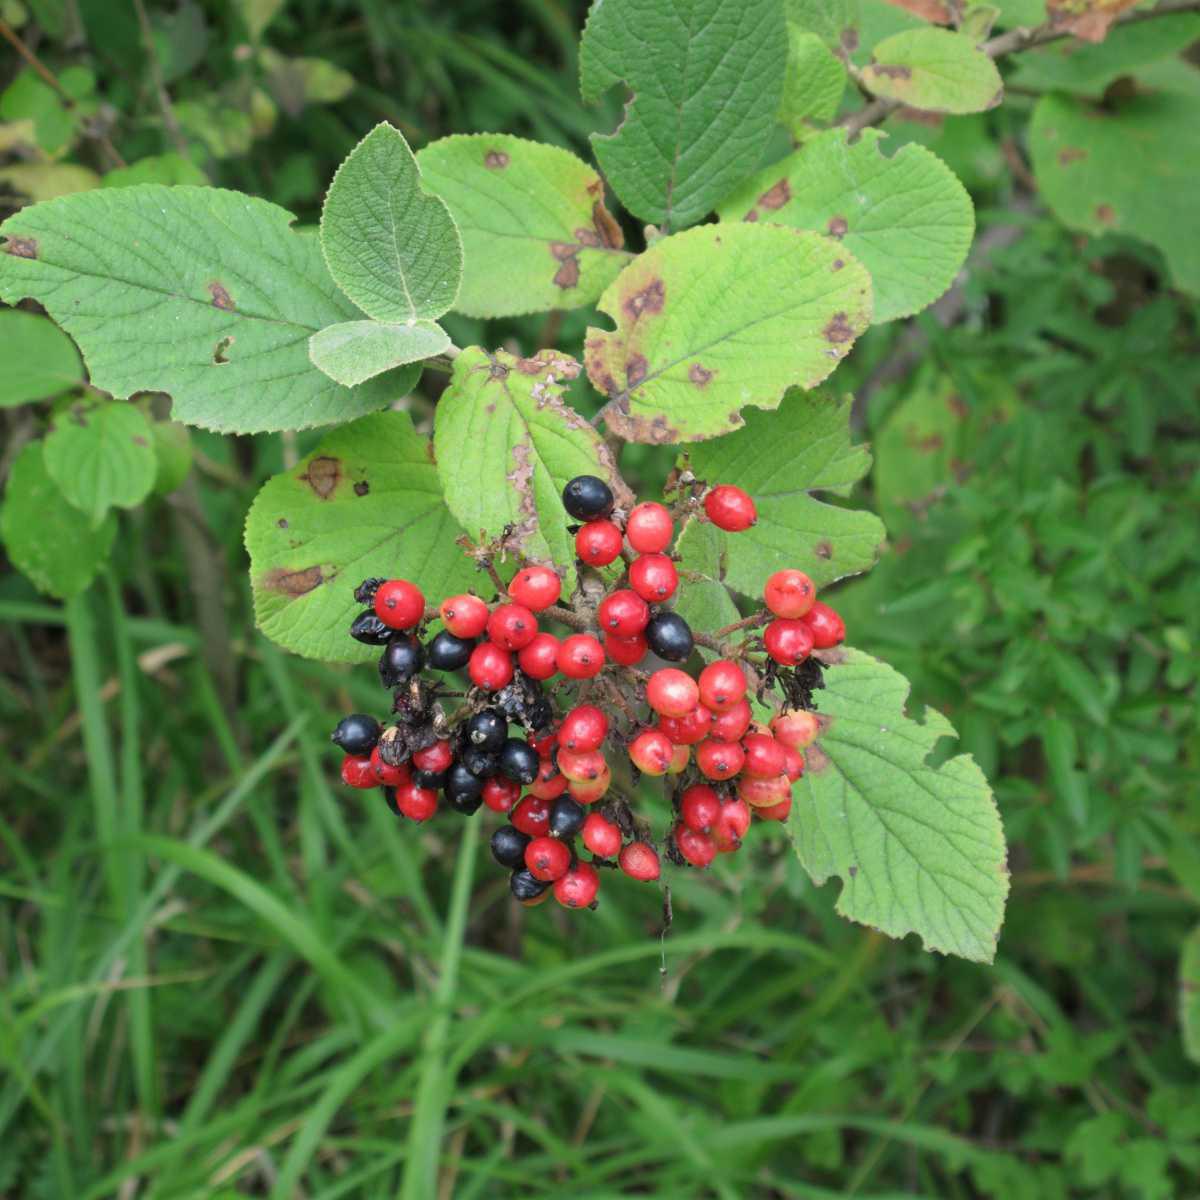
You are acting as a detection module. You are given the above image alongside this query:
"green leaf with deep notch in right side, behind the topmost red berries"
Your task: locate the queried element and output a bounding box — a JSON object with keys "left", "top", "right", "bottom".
{"left": 689, "top": 391, "right": 884, "bottom": 599}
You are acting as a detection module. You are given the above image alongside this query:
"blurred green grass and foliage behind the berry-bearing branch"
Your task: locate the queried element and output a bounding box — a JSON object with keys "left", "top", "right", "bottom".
{"left": 0, "top": 0, "right": 1200, "bottom": 1198}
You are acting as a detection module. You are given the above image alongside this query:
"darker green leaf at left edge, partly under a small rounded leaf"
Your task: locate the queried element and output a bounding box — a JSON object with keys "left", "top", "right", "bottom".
{"left": 0, "top": 442, "right": 116, "bottom": 600}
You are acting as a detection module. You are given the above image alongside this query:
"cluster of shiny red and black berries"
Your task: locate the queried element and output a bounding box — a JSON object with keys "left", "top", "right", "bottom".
{"left": 332, "top": 475, "right": 845, "bottom": 908}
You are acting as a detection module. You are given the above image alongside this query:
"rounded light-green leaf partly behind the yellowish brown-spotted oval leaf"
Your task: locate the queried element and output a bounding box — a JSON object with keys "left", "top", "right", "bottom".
{"left": 720, "top": 130, "right": 974, "bottom": 322}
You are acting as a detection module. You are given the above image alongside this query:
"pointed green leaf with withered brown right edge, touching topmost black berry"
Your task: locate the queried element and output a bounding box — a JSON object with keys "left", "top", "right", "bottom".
{"left": 434, "top": 347, "right": 619, "bottom": 584}
